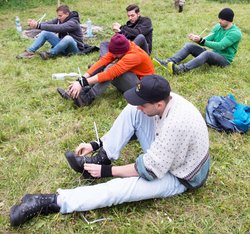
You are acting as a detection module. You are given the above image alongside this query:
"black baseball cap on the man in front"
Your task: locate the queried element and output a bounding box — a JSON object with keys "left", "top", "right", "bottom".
{"left": 124, "top": 75, "right": 171, "bottom": 106}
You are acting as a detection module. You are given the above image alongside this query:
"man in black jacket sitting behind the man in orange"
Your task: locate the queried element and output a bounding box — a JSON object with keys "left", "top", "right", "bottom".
{"left": 100, "top": 4, "right": 153, "bottom": 56}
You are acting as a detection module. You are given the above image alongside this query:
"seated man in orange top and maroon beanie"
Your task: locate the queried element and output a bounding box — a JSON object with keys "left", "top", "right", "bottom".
{"left": 57, "top": 33, "right": 154, "bottom": 107}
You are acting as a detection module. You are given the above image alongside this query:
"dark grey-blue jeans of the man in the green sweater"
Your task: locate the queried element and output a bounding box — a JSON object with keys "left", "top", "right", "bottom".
{"left": 168, "top": 43, "right": 229, "bottom": 72}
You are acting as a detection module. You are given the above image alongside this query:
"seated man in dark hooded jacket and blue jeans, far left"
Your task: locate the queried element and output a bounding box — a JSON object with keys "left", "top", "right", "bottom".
{"left": 17, "top": 5, "right": 84, "bottom": 60}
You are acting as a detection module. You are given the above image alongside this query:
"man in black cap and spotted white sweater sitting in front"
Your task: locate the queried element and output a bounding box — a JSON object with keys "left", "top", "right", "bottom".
{"left": 10, "top": 75, "right": 210, "bottom": 226}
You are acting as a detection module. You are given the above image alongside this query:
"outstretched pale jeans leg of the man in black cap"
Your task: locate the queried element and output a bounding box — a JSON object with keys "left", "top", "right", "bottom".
{"left": 57, "top": 173, "right": 186, "bottom": 214}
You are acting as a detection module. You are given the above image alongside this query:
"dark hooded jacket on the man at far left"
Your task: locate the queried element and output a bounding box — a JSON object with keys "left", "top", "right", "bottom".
{"left": 38, "top": 11, "right": 84, "bottom": 51}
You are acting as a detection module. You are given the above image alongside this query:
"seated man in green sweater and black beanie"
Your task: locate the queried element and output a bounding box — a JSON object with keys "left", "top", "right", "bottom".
{"left": 154, "top": 8, "right": 242, "bottom": 74}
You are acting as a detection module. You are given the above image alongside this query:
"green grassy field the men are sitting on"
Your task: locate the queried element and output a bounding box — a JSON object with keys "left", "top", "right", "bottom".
{"left": 0, "top": 0, "right": 250, "bottom": 233}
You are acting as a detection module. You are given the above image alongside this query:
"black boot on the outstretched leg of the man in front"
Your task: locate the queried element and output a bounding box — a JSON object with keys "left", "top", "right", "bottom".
{"left": 10, "top": 194, "right": 60, "bottom": 226}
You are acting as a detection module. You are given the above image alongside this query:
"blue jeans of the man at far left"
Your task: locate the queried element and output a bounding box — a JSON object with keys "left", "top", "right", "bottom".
{"left": 27, "top": 31, "right": 79, "bottom": 56}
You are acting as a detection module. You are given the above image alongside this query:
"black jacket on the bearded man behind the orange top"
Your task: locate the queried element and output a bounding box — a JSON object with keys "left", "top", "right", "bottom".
{"left": 120, "top": 16, "right": 153, "bottom": 53}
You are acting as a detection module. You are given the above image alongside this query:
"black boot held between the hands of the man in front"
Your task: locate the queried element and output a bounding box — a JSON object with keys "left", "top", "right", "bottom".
{"left": 65, "top": 148, "right": 111, "bottom": 178}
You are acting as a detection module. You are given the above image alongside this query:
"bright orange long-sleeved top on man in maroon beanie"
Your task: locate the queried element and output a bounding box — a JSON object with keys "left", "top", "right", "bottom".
{"left": 87, "top": 42, "right": 155, "bottom": 83}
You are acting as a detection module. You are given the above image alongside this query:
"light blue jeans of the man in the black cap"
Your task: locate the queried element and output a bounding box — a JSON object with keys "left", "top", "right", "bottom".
{"left": 57, "top": 105, "right": 186, "bottom": 214}
